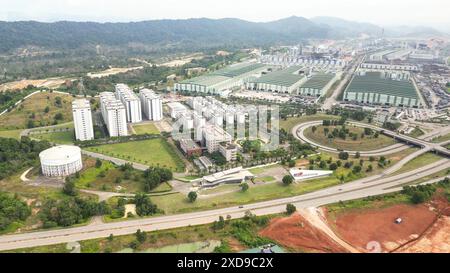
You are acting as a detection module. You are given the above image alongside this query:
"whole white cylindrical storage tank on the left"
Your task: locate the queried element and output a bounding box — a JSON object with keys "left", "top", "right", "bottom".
{"left": 39, "top": 145, "right": 83, "bottom": 176}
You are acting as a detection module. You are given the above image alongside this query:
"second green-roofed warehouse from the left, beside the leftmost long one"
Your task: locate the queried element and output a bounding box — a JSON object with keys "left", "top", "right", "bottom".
{"left": 245, "top": 66, "right": 306, "bottom": 94}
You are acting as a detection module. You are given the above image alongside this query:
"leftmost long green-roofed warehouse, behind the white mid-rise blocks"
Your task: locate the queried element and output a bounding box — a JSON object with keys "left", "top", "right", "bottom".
{"left": 174, "top": 62, "right": 268, "bottom": 94}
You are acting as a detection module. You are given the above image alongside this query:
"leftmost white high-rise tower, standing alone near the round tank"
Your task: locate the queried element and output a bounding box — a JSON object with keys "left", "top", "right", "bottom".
{"left": 72, "top": 99, "right": 94, "bottom": 141}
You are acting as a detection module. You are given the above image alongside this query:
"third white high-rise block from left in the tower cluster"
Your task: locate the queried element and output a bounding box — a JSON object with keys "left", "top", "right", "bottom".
{"left": 115, "top": 83, "right": 142, "bottom": 123}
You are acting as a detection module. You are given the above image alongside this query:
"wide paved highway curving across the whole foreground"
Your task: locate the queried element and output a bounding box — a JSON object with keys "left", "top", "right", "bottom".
{"left": 0, "top": 156, "right": 450, "bottom": 250}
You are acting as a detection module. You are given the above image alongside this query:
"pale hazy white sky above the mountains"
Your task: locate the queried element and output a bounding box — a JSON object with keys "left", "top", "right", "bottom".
{"left": 0, "top": 0, "right": 450, "bottom": 28}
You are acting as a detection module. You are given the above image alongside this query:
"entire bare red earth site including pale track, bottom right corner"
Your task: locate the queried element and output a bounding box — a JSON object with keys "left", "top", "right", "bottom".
{"left": 260, "top": 198, "right": 450, "bottom": 253}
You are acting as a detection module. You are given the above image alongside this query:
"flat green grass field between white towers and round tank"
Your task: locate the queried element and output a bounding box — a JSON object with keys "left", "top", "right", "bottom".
{"left": 87, "top": 138, "right": 184, "bottom": 171}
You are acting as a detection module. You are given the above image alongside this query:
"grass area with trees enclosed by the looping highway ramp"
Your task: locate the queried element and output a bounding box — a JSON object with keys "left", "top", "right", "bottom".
{"left": 305, "top": 126, "right": 397, "bottom": 151}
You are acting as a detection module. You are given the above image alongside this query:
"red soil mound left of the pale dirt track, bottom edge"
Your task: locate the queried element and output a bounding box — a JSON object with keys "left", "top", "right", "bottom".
{"left": 260, "top": 213, "right": 347, "bottom": 252}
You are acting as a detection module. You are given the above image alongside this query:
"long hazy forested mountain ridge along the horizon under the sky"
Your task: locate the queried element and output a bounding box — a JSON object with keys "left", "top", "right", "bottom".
{"left": 0, "top": 16, "right": 442, "bottom": 52}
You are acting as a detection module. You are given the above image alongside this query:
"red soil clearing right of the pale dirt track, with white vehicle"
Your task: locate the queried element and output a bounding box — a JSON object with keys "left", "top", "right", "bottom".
{"left": 334, "top": 204, "right": 437, "bottom": 252}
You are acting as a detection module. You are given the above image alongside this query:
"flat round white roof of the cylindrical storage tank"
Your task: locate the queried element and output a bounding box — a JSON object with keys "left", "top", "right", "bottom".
{"left": 39, "top": 145, "right": 81, "bottom": 165}
